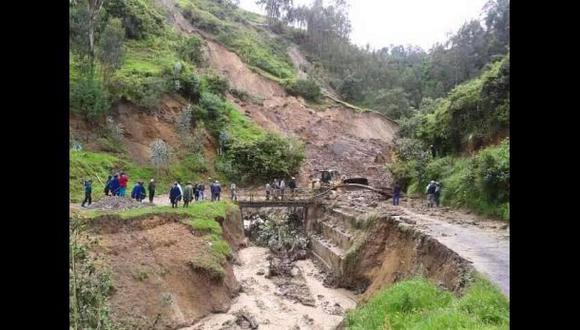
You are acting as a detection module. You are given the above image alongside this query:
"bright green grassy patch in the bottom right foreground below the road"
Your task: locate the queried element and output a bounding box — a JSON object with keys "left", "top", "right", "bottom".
{"left": 347, "top": 278, "right": 509, "bottom": 330}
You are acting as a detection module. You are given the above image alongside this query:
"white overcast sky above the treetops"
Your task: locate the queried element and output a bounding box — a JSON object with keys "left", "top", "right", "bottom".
{"left": 240, "top": 0, "right": 487, "bottom": 50}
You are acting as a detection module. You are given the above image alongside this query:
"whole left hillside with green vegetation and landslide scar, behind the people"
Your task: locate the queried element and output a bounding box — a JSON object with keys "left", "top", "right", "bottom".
{"left": 70, "top": 0, "right": 397, "bottom": 200}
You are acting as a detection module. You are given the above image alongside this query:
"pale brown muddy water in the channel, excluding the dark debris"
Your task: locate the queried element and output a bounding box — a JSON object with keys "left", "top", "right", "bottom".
{"left": 184, "top": 247, "right": 356, "bottom": 330}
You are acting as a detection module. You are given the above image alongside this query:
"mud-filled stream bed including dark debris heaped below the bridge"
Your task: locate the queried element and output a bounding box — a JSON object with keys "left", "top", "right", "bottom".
{"left": 185, "top": 210, "right": 356, "bottom": 330}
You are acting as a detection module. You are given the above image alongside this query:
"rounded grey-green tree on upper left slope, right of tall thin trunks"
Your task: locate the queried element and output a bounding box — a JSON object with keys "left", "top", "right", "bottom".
{"left": 97, "top": 18, "right": 125, "bottom": 81}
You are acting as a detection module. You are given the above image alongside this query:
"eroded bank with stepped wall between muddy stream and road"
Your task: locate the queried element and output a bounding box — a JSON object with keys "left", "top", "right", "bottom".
{"left": 308, "top": 204, "right": 473, "bottom": 300}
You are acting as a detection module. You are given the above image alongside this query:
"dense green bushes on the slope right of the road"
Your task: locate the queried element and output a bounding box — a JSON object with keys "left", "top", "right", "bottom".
{"left": 388, "top": 54, "right": 510, "bottom": 220}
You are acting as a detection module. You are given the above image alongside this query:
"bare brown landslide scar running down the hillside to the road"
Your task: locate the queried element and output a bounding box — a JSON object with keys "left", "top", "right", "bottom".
{"left": 152, "top": 0, "right": 398, "bottom": 185}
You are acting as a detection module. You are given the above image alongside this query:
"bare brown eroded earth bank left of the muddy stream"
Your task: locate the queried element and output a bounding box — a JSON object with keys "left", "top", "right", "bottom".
{"left": 89, "top": 209, "right": 243, "bottom": 329}
